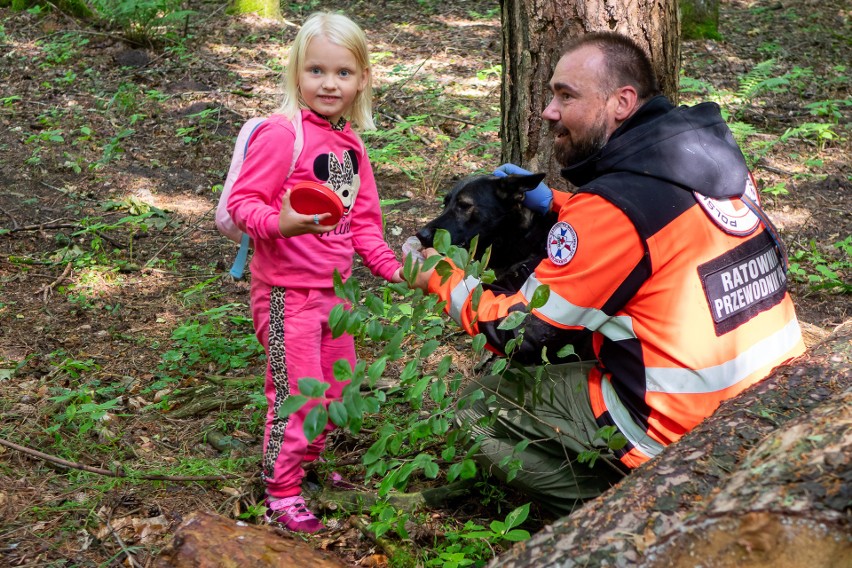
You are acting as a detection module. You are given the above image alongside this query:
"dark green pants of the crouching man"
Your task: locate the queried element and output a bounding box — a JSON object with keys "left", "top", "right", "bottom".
{"left": 456, "top": 362, "right": 626, "bottom": 515}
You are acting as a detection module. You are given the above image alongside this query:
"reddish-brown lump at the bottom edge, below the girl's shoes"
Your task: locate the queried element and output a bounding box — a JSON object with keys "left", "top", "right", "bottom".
{"left": 153, "top": 511, "right": 344, "bottom": 568}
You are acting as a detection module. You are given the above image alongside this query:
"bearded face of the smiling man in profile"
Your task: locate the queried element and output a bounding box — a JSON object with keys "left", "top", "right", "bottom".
{"left": 541, "top": 46, "right": 616, "bottom": 167}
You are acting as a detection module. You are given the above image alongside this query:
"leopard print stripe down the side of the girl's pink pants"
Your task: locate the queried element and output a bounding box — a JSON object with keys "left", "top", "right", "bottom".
{"left": 262, "top": 287, "right": 290, "bottom": 482}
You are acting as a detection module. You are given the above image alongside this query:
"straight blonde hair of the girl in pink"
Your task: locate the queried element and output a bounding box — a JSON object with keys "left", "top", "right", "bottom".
{"left": 275, "top": 12, "right": 376, "bottom": 131}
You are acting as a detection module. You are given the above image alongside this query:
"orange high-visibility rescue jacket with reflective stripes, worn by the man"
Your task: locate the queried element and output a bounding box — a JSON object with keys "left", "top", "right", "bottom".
{"left": 429, "top": 98, "right": 804, "bottom": 467}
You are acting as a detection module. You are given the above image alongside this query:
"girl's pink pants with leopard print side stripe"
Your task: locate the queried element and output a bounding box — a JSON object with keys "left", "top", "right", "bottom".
{"left": 251, "top": 280, "right": 355, "bottom": 499}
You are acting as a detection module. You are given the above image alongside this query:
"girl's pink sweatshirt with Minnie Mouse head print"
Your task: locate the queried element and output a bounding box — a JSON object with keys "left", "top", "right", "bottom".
{"left": 228, "top": 110, "right": 400, "bottom": 288}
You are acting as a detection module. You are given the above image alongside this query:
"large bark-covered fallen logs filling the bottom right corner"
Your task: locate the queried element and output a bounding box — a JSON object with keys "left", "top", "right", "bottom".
{"left": 489, "top": 321, "right": 852, "bottom": 568}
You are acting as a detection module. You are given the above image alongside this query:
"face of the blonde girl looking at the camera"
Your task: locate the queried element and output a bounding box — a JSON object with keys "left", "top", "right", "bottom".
{"left": 299, "top": 36, "right": 369, "bottom": 124}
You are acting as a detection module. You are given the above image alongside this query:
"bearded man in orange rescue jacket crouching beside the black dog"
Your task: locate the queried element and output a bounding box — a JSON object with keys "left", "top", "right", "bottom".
{"left": 415, "top": 32, "right": 804, "bottom": 514}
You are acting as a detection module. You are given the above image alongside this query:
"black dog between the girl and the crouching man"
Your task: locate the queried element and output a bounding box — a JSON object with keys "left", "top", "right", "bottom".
{"left": 417, "top": 174, "right": 557, "bottom": 290}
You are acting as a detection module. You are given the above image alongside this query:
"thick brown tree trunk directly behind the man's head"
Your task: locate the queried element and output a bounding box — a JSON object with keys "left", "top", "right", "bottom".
{"left": 500, "top": 0, "right": 680, "bottom": 188}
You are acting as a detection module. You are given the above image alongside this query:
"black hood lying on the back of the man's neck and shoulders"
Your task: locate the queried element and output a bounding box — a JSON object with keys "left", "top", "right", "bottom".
{"left": 562, "top": 96, "right": 748, "bottom": 198}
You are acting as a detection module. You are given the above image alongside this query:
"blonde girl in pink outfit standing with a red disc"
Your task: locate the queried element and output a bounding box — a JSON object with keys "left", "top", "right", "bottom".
{"left": 228, "top": 13, "right": 402, "bottom": 533}
